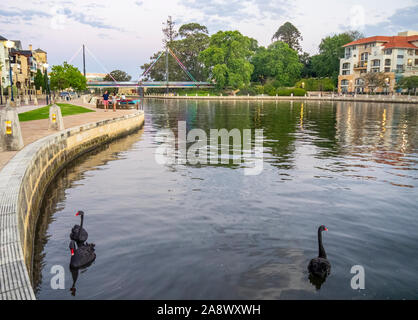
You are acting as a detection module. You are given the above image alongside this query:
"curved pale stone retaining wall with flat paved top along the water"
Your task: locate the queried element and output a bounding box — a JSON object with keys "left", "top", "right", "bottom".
{"left": 0, "top": 111, "right": 144, "bottom": 300}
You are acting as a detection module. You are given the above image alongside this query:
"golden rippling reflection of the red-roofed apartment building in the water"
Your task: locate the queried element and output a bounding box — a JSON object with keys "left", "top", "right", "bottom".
{"left": 336, "top": 102, "right": 418, "bottom": 166}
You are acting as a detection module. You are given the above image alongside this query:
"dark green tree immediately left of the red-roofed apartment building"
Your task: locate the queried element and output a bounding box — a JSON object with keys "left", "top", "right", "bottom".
{"left": 312, "top": 31, "right": 360, "bottom": 83}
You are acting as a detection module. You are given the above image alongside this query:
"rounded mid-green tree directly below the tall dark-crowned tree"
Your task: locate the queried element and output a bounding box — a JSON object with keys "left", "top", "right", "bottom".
{"left": 251, "top": 41, "right": 303, "bottom": 87}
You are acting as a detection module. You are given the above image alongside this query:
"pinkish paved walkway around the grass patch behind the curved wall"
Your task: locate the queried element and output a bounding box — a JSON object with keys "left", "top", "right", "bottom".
{"left": 0, "top": 99, "right": 136, "bottom": 171}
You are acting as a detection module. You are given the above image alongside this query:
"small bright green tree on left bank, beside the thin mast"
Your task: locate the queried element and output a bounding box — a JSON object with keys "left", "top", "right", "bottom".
{"left": 50, "top": 62, "right": 87, "bottom": 91}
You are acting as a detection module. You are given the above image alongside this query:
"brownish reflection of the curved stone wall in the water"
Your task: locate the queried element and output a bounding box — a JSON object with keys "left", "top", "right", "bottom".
{"left": 32, "top": 130, "right": 143, "bottom": 294}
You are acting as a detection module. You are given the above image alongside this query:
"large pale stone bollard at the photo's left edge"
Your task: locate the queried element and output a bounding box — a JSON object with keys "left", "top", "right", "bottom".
{"left": 0, "top": 105, "right": 24, "bottom": 151}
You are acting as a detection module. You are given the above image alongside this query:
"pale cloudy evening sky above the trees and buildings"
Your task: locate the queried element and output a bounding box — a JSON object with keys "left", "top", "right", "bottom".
{"left": 0, "top": 0, "right": 418, "bottom": 78}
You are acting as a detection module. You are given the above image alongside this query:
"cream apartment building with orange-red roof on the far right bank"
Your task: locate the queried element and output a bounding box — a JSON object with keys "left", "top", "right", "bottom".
{"left": 338, "top": 31, "right": 418, "bottom": 93}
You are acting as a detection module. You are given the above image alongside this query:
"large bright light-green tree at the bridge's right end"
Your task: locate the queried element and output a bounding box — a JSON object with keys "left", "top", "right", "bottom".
{"left": 199, "top": 31, "right": 256, "bottom": 88}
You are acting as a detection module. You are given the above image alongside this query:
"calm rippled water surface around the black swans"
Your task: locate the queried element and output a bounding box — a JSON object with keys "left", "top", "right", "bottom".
{"left": 33, "top": 100, "right": 418, "bottom": 299}
